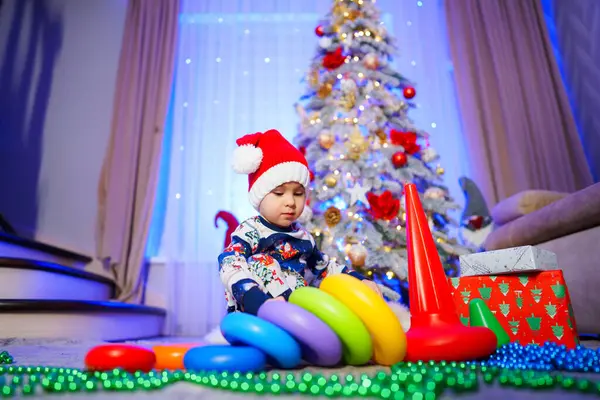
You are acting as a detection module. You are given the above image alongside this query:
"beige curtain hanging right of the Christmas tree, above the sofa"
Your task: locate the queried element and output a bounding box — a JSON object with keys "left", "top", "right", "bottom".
{"left": 445, "top": 0, "right": 592, "bottom": 205}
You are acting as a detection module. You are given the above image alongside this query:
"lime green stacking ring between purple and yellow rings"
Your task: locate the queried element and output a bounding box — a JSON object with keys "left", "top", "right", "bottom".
{"left": 289, "top": 286, "right": 373, "bottom": 365}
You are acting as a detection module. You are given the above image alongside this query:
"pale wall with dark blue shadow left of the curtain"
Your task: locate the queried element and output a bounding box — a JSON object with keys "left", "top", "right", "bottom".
{"left": 0, "top": 0, "right": 127, "bottom": 255}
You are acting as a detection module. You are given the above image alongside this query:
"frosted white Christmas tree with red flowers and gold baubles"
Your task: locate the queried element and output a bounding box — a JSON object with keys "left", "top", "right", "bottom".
{"left": 294, "top": 0, "right": 468, "bottom": 300}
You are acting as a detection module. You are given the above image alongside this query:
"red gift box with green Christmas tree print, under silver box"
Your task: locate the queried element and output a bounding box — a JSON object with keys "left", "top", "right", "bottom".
{"left": 448, "top": 270, "right": 579, "bottom": 348}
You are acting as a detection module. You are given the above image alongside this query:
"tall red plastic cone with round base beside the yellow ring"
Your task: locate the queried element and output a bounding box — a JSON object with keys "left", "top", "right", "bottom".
{"left": 404, "top": 183, "right": 496, "bottom": 361}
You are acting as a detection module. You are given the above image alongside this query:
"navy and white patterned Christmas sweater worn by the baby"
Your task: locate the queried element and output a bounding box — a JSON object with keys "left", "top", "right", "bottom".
{"left": 219, "top": 216, "right": 365, "bottom": 314}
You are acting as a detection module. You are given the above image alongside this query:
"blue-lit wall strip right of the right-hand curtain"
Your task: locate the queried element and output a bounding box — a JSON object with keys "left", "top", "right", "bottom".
{"left": 542, "top": 0, "right": 600, "bottom": 182}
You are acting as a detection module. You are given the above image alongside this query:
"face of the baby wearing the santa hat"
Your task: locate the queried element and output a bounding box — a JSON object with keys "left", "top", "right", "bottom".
{"left": 258, "top": 182, "right": 306, "bottom": 228}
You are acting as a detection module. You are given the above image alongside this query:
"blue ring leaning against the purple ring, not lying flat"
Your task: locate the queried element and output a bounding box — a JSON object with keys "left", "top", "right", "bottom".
{"left": 221, "top": 312, "right": 301, "bottom": 368}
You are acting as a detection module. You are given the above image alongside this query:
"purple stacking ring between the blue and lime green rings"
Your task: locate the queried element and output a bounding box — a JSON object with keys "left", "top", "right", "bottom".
{"left": 257, "top": 301, "right": 342, "bottom": 367}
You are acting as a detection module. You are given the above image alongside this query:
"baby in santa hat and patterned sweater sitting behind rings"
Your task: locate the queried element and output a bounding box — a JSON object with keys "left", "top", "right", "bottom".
{"left": 219, "top": 130, "right": 381, "bottom": 315}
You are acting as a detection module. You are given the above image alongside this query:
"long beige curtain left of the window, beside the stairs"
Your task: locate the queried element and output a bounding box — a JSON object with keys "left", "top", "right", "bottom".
{"left": 96, "top": 0, "right": 180, "bottom": 303}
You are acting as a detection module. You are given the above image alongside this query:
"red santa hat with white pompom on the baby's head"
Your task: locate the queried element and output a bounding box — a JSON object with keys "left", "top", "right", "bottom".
{"left": 233, "top": 129, "right": 310, "bottom": 210}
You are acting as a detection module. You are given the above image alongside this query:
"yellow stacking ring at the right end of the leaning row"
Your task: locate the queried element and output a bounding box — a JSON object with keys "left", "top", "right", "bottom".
{"left": 319, "top": 274, "right": 406, "bottom": 365}
